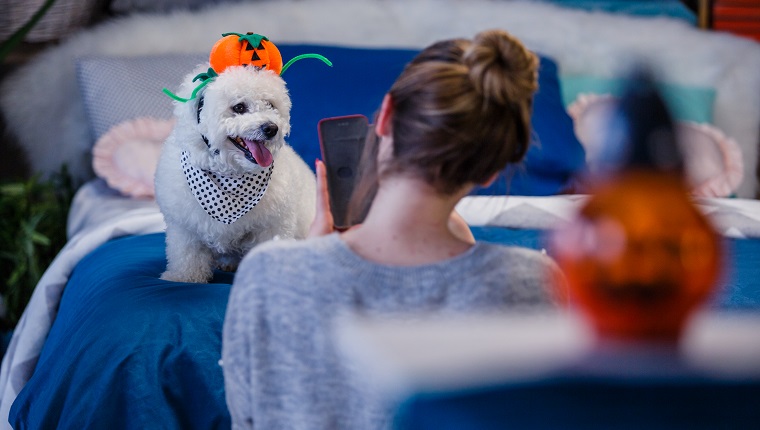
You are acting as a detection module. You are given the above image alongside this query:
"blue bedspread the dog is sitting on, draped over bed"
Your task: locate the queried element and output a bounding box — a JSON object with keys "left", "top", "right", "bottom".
{"left": 10, "top": 227, "right": 760, "bottom": 429}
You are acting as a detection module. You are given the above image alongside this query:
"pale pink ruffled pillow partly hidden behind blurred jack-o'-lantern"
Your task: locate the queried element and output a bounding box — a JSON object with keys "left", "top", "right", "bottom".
{"left": 567, "top": 94, "right": 744, "bottom": 197}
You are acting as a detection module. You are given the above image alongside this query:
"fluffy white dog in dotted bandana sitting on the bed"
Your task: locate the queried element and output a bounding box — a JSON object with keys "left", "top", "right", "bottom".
{"left": 156, "top": 65, "right": 316, "bottom": 283}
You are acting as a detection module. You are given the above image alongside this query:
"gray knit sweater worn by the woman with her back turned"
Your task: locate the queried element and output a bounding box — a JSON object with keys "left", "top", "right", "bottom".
{"left": 222, "top": 234, "right": 558, "bottom": 430}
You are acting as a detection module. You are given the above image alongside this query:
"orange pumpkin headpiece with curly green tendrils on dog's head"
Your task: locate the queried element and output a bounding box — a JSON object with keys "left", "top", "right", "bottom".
{"left": 163, "top": 33, "right": 332, "bottom": 103}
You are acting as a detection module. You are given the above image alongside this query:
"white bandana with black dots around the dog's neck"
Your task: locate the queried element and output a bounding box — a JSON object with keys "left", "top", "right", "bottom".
{"left": 182, "top": 151, "right": 274, "bottom": 224}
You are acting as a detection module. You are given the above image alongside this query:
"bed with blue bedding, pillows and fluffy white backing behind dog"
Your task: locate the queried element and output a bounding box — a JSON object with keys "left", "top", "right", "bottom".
{"left": 0, "top": 0, "right": 760, "bottom": 428}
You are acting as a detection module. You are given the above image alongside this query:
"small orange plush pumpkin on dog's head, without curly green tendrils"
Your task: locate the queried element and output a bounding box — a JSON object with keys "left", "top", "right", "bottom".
{"left": 209, "top": 33, "right": 282, "bottom": 75}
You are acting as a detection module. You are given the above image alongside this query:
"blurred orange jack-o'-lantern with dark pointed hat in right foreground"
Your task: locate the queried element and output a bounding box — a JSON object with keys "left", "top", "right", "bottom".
{"left": 553, "top": 69, "right": 722, "bottom": 344}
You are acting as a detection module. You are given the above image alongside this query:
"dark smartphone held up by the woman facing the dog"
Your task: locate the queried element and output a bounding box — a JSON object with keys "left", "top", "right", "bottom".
{"left": 317, "top": 115, "right": 369, "bottom": 230}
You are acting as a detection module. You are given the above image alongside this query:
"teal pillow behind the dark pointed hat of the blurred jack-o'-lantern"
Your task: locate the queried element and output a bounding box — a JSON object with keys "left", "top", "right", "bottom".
{"left": 560, "top": 75, "right": 715, "bottom": 124}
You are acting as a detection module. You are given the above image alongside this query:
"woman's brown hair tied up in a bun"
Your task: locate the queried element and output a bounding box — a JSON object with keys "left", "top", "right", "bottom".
{"left": 352, "top": 30, "right": 538, "bottom": 221}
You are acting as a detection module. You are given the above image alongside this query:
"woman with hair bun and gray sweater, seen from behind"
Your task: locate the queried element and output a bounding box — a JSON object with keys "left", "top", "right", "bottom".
{"left": 222, "top": 30, "right": 561, "bottom": 429}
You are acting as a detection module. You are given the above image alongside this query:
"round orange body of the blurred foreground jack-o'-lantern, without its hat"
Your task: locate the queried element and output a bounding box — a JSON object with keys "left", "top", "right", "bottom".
{"left": 553, "top": 172, "right": 721, "bottom": 341}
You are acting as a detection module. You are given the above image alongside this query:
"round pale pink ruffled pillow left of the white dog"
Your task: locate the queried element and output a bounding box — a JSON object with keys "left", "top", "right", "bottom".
{"left": 92, "top": 117, "right": 174, "bottom": 198}
